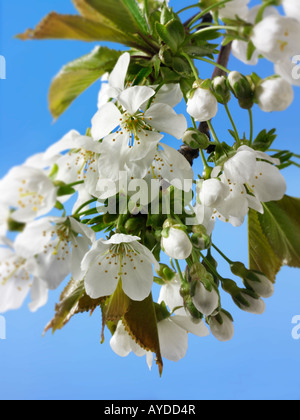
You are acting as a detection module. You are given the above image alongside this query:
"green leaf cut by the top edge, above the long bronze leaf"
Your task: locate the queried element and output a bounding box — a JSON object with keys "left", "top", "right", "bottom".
{"left": 85, "top": 0, "right": 146, "bottom": 34}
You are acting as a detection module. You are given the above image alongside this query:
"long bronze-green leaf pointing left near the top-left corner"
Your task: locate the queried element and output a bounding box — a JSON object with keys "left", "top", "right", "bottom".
{"left": 17, "top": 12, "right": 138, "bottom": 46}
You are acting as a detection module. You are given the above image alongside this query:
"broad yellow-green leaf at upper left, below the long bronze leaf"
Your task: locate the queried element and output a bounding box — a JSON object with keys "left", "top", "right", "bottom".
{"left": 49, "top": 47, "right": 121, "bottom": 118}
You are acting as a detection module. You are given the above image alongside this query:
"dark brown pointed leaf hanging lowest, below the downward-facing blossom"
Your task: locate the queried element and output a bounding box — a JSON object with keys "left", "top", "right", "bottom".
{"left": 123, "top": 294, "right": 163, "bottom": 375}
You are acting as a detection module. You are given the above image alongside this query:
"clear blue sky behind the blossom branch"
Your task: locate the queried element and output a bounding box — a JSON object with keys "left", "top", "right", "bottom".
{"left": 0, "top": 0, "right": 300, "bottom": 400}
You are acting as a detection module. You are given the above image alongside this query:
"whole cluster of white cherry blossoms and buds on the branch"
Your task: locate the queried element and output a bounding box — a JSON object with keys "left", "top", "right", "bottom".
{"left": 0, "top": 0, "right": 300, "bottom": 374}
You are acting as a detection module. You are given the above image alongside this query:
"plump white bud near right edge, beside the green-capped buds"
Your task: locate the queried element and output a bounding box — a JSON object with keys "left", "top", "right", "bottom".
{"left": 255, "top": 77, "right": 294, "bottom": 112}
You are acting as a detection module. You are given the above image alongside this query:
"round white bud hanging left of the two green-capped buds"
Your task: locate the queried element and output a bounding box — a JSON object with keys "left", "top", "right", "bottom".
{"left": 187, "top": 88, "right": 218, "bottom": 122}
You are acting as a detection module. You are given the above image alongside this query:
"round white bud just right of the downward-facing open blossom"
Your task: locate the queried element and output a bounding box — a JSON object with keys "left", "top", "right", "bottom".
{"left": 161, "top": 227, "right": 193, "bottom": 260}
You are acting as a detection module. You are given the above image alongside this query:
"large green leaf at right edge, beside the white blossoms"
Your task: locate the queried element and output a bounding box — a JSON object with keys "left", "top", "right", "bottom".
{"left": 249, "top": 196, "right": 300, "bottom": 281}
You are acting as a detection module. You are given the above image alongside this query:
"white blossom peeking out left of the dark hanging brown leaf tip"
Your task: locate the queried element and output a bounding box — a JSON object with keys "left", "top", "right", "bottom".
{"left": 110, "top": 321, "right": 153, "bottom": 369}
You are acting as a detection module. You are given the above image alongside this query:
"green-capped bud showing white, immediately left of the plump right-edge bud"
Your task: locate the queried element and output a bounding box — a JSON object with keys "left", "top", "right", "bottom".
{"left": 227, "top": 71, "right": 254, "bottom": 109}
